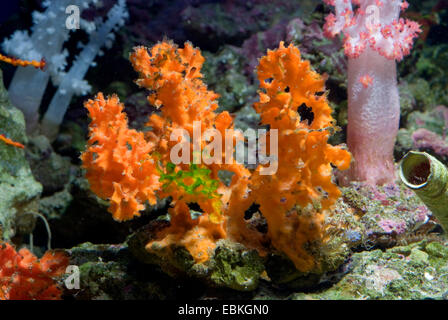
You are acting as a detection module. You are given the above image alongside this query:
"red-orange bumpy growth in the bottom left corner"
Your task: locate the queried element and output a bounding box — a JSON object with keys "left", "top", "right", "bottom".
{"left": 0, "top": 243, "right": 69, "bottom": 300}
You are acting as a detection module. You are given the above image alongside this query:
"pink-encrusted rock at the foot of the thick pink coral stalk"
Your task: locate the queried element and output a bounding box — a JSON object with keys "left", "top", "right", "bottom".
{"left": 340, "top": 182, "right": 436, "bottom": 249}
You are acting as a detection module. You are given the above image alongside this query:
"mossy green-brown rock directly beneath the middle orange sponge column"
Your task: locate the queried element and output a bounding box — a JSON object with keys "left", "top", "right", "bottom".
{"left": 128, "top": 220, "right": 264, "bottom": 291}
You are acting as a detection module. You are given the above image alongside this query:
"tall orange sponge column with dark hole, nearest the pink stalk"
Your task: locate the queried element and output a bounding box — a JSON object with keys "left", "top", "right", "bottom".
{"left": 250, "top": 42, "right": 351, "bottom": 271}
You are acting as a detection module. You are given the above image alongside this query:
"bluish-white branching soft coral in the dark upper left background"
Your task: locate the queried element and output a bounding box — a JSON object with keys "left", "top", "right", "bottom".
{"left": 2, "top": 0, "right": 128, "bottom": 136}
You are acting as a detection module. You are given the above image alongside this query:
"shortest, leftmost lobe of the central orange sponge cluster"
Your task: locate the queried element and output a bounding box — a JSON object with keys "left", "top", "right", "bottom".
{"left": 81, "top": 93, "right": 159, "bottom": 221}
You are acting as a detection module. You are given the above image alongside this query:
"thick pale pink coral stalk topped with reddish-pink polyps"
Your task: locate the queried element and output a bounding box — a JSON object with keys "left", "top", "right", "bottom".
{"left": 324, "top": 0, "right": 421, "bottom": 184}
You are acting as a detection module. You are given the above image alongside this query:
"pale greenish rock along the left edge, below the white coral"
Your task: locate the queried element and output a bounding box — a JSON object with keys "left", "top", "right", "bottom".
{"left": 0, "top": 70, "right": 42, "bottom": 239}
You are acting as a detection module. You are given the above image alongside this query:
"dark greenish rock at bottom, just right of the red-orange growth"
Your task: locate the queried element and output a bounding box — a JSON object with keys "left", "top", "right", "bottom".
{"left": 64, "top": 242, "right": 176, "bottom": 300}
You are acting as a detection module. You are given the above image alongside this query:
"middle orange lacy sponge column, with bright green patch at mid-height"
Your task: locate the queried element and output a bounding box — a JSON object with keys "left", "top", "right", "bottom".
{"left": 130, "top": 41, "right": 250, "bottom": 262}
